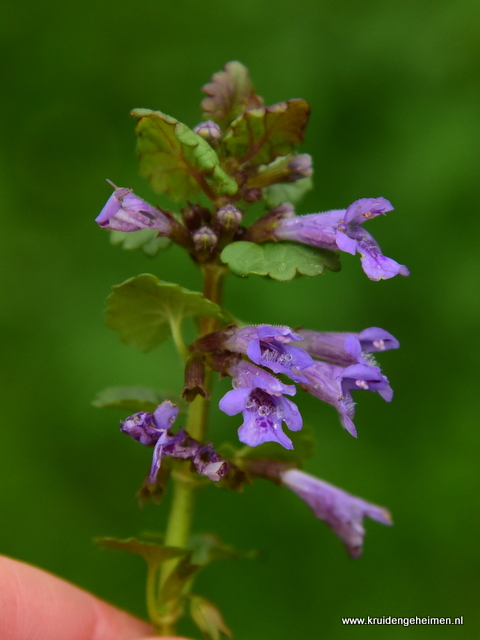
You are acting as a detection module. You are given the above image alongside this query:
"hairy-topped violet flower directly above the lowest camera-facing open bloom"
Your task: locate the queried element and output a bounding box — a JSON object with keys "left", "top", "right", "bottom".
{"left": 223, "top": 325, "right": 313, "bottom": 382}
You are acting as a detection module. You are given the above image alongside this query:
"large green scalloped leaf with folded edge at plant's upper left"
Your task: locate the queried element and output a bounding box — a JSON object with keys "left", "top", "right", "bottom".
{"left": 131, "top": 109, "right": 238, "bottom": 201}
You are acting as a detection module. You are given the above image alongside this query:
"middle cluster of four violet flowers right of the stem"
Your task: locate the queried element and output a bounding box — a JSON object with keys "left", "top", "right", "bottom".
{"left": 219, "top": 325, "right": 399, "bottom": 442}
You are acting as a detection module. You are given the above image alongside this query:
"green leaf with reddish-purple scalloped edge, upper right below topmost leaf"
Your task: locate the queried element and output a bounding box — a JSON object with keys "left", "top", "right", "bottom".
{"left": 224, "top": 99, "right": 310, "bottom": 166}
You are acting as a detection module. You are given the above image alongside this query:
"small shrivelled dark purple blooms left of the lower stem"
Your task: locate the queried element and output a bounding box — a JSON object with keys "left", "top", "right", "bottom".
{"left": 120, "top": 400, "right": 228, "bottom": 484}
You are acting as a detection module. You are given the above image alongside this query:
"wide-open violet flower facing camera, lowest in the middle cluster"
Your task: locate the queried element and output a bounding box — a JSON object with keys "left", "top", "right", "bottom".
{"left": 219, "top": 360, "right": 303, "bottom": 449}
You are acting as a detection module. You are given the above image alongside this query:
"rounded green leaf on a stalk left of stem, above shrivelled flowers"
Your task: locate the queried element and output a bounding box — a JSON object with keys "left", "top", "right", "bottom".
{"left": 105, "top": 273, "right": 223, "bottom": 351}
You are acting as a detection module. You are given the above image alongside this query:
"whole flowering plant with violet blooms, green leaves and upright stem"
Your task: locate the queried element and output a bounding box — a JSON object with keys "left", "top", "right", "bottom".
{"left": 96, "top": 62, "right": 408, "bottom": 640}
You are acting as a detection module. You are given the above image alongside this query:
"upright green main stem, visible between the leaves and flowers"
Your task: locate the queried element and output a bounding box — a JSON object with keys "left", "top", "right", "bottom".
{"left": 153, "top": 264, "right": 226, "bottom": 635}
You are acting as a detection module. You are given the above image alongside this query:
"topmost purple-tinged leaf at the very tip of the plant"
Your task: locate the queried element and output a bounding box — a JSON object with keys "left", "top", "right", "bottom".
{"left": 201, "top": 60, "right": 263, "bottom": 129}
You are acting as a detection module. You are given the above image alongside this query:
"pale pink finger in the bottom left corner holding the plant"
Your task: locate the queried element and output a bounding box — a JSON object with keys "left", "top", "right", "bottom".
{"left": 0, "top": 556, "right": 191, "bottom": 640}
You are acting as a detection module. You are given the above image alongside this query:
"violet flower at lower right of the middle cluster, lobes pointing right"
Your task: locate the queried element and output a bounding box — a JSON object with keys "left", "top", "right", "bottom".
{"left": 302, "top": 361, "right": 393, "bottom": 438}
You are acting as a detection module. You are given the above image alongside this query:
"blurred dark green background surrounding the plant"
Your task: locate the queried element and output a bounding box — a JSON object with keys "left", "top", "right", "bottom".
{"left": 0, "top": 0, "right": 480, "bottom": 640}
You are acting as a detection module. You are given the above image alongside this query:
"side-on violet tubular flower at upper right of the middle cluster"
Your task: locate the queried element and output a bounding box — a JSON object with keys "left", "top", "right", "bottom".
{"left": 298, "top": 327, "right": 400, "bottom": 367}
